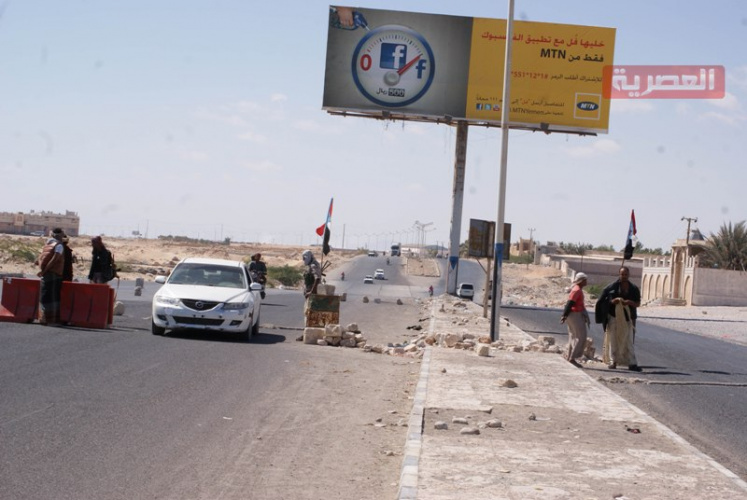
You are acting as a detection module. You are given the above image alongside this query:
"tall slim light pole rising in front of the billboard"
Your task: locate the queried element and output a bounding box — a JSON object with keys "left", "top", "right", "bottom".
{"left": 490, "top": 0, "right": 514, "bottom": 341}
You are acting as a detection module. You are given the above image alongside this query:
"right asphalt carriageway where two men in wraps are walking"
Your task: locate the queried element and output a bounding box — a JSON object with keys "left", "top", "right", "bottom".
{"left": 501, "top": 306, "right": 747, "bottom": 480}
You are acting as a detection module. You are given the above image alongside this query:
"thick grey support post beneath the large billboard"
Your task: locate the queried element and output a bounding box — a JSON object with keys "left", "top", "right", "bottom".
{"left": 446, "top": 121, "right": 469, "bottom": 295}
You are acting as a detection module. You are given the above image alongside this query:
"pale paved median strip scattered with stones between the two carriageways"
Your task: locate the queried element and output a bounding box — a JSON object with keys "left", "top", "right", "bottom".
{"left": 399, "top": 298, "right": 747, "bottom": 500}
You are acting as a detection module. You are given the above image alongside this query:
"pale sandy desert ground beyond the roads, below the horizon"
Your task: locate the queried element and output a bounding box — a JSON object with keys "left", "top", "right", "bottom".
{"left": 0, "top": 234, "right": 747, "bottom": 344}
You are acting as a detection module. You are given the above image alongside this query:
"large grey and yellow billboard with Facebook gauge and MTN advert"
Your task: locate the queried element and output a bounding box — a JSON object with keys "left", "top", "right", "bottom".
{"left": 322, "top": 7, "right": 615, "bottom": 133}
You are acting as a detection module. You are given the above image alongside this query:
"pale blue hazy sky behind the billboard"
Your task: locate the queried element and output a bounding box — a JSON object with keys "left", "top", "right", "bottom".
{"left": 0, "top": 0, "right": 747, "bottom": 254}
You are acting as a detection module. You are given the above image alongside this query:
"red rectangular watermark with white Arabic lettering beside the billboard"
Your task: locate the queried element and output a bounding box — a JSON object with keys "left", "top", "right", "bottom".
{"left": 602, "top": 66, "right": 726, "bottom": 99}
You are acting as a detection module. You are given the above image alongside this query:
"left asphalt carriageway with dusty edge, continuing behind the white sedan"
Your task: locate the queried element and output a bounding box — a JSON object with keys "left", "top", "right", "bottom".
{"left": 0, "top": 258, "right": 427, "bottom": 500}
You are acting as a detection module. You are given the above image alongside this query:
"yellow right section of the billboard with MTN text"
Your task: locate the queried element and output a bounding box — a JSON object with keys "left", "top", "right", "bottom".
{"left": 466, "top": 18, "right": 615, "bottom": 132}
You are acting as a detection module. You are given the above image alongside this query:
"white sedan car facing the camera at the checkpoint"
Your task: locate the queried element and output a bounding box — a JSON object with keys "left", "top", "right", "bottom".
{"left": 151, "top": 258, "right": 262, "bottom": 340}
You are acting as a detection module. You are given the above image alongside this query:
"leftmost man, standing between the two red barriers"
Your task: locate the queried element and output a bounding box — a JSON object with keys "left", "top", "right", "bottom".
{"left": 36, "top": 228, "right": 66, "bottom": 325}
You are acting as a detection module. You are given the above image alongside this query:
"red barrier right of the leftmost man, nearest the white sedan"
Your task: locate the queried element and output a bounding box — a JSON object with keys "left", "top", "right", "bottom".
{"left": 60, "top": 281, "right": 115, "bottom": 328}
